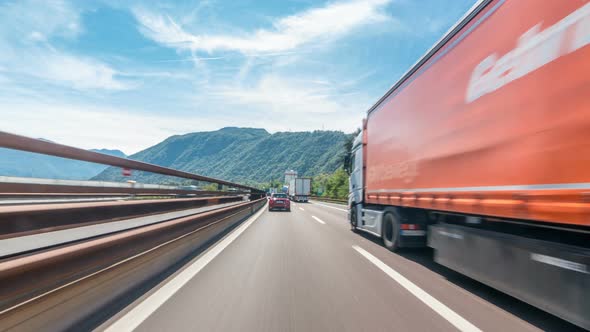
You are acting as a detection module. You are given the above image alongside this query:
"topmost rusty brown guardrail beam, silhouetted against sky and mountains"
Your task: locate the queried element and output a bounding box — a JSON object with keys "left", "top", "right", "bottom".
{"left": 0, "top": 131, "right": 262, "bottom": 194}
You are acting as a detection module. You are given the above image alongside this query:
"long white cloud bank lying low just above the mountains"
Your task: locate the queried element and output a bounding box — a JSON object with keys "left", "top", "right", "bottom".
{"left": 0, "top": 76, "right": 370, "bottom": 154}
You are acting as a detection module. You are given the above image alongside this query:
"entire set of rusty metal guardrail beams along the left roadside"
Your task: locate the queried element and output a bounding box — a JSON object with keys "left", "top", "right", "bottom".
{"left": 0, "top": 131, "right": 266, "bottom": 330}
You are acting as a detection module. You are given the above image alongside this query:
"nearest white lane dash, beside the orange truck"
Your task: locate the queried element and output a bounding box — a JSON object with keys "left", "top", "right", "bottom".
{"left": 352, "top": 245, "right": 481, "bottom": 332}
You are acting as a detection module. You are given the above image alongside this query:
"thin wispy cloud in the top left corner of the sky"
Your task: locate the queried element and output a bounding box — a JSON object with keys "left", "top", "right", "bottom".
{"left": 0, "top": 0, "right": 130, "bottom": 90}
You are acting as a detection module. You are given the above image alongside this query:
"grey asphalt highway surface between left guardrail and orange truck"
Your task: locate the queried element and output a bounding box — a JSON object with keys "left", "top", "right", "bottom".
{"left": 99, "top": 202, "right": 580, "bottom": 331}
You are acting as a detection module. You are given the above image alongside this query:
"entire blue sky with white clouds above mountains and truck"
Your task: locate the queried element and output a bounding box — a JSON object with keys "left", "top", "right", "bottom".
{"left": 0, "top": 0, "right": 475, "bottom": 153}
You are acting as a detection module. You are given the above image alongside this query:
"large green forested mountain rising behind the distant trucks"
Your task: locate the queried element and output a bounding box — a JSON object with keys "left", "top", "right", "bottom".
{"left": 93, "top": 127, "right": 347, "bottom": 184}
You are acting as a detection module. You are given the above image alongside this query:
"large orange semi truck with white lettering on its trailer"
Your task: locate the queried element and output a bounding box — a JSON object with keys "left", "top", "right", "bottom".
{"left": 349, "top": 0, "right": 590, "bottom": 329}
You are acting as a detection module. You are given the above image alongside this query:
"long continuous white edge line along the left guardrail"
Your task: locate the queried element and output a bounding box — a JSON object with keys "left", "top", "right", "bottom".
{"left": 105, "top": 207, "right": 266, "bottom": 332}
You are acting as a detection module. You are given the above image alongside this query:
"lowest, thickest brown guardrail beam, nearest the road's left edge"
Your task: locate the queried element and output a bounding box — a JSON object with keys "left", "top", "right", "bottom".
{"left": 0, "top": 198, "right": 266, "bottom": 330}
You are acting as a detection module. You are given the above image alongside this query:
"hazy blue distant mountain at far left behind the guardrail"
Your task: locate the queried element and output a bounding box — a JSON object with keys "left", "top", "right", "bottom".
{"left": 0, "top": 148, "right": 125, "bottom": 180}
